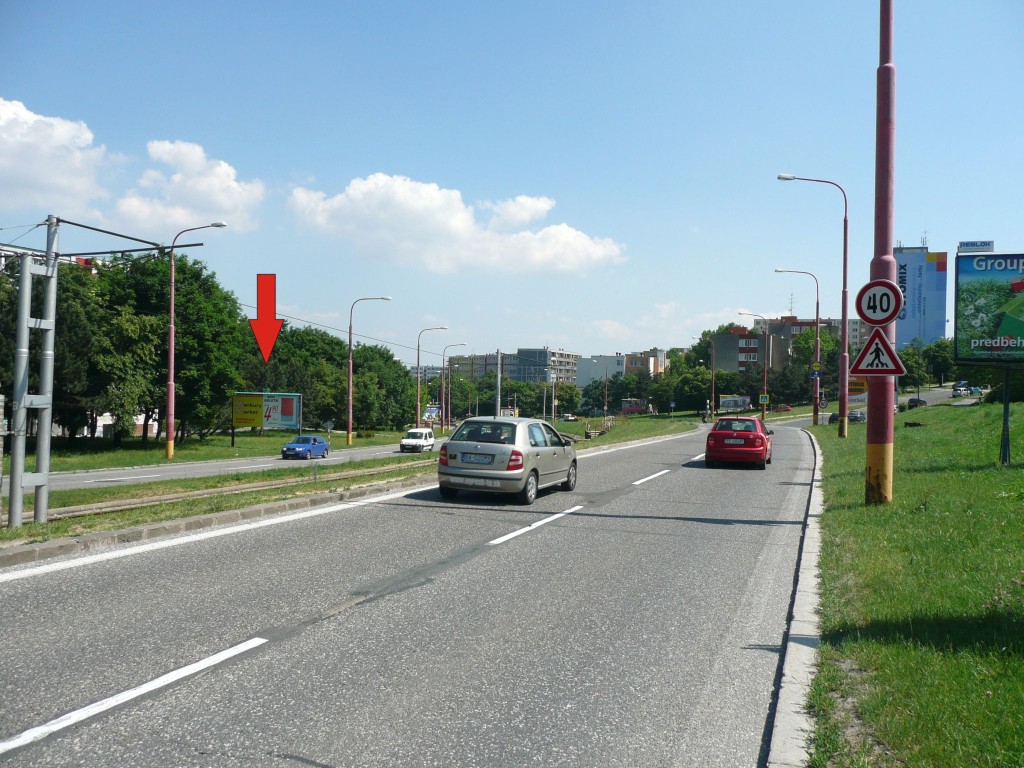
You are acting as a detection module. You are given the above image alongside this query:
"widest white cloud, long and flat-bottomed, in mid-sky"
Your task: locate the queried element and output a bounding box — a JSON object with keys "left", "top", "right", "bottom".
{"left": 289, "top": 173, "right": 624, "bottom": 272}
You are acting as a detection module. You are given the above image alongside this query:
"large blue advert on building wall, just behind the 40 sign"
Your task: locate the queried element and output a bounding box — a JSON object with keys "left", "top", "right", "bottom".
{"left": 893, "top": 247, "right": 947, "bottom": 349}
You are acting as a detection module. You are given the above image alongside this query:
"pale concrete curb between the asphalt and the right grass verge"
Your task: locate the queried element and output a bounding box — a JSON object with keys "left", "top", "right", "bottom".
{"left": 768, "top": 432, "right": 824, "bottom": 768}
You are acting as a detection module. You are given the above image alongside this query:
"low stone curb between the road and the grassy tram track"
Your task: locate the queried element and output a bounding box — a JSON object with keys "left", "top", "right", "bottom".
{"left": 0, "top": 475, "right": 432, "bottom": 568}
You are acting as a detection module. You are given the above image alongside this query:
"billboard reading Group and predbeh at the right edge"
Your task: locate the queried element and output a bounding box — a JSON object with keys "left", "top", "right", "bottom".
{"left": 953, "top": 253, "right": 1024, "bottom": 365}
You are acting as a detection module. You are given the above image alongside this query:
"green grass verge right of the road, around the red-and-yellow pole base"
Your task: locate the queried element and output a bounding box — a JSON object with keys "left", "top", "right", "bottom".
{"left": 812, "top": 406, "right": 1024, "bottom": 768}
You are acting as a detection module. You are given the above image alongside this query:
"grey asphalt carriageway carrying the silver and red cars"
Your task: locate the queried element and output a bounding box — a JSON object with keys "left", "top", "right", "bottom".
{"left": 0, "top": 425, "right": 814, "bottom": 768}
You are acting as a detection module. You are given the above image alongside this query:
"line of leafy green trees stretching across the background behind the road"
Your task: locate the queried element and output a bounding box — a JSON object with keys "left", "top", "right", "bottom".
{"left": 0, "top": 259, "right": 1007, "bottom": 441}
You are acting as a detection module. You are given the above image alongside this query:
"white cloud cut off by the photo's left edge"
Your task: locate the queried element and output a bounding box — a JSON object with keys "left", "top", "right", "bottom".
{"left": 0, "top": 98, "right": 106, "bottom": 216}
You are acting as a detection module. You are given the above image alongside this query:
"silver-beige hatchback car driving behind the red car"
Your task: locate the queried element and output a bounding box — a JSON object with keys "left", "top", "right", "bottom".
{"left": 437, "top": 416, "right": 577, "bottom": 504}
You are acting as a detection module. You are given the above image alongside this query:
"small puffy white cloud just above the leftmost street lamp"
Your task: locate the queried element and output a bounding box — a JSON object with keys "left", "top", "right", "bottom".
{"left": 117, "top": 141, "right": 266, "bottom": 231}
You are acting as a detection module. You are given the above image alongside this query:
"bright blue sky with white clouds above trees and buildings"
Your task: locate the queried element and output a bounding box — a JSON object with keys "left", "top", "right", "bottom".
{"left": 0, "top": 0, "right": 1024, "bottom": 364}
